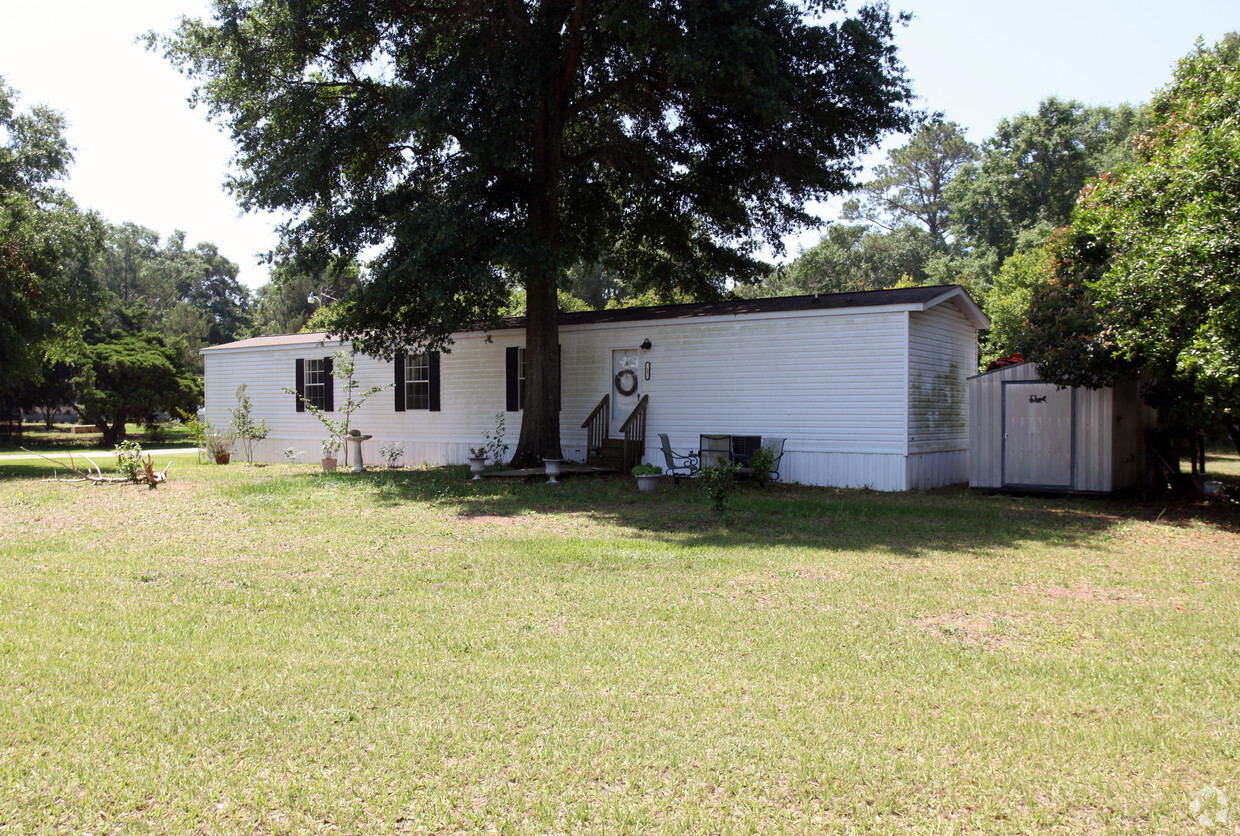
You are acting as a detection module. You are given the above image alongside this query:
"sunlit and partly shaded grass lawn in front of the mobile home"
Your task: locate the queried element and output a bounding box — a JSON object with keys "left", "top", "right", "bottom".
{"left": 0, "top": 453, "right": 1240, "bottom": 834}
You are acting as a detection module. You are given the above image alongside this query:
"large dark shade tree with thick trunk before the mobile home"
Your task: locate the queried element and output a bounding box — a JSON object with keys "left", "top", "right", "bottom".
{"left": 157, "top": 0, "right": 909, "bottom": 464}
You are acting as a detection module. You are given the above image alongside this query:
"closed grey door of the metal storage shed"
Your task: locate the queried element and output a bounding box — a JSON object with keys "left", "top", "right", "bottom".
{"left": 1003, "top": 381, "right": 1075, "bottom": 489}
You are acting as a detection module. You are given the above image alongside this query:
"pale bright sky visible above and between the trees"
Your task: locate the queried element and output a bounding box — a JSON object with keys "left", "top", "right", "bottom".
{"left": 0, "top": 0, "right": 1240, "bottom": 288}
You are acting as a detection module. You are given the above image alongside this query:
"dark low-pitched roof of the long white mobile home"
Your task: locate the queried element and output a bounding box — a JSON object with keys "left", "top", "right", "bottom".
{"left": 202, "top": 284, "right": 990, "bottom": 352}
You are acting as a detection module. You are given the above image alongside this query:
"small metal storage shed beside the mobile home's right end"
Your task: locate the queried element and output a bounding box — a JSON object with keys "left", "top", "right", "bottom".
{"left": 968, "top": 362, "right": 1145, "bottom": 494}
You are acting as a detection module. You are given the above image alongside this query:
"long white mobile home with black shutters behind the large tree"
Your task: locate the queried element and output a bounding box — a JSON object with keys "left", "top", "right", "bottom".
{"left": 202, "top": 285, "right": 987, "bottom": 490}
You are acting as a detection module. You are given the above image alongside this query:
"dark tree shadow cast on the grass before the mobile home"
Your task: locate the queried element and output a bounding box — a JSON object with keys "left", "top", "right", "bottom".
{"left": 266, "top": 468, "right": 1240, "bottom": 558}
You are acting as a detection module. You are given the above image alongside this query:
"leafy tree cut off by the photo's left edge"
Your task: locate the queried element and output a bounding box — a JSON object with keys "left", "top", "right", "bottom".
{"left": 0, "top": 79, "right": 103, "bottom": 398}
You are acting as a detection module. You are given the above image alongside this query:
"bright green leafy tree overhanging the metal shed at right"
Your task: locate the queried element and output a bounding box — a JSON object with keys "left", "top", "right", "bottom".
{"left": 1030, "top": 33, "right": 1240, "bottom": 449}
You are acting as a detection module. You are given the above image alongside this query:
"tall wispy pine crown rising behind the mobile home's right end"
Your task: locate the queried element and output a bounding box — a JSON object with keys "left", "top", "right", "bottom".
{"left": 842, "top": 120, "right": 977, "bottom": 248}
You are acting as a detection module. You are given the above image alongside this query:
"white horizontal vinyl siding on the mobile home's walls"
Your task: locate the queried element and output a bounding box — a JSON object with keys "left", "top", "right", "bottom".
{"left": 203, "top": 291, "right": 976, "bottom": 490}
